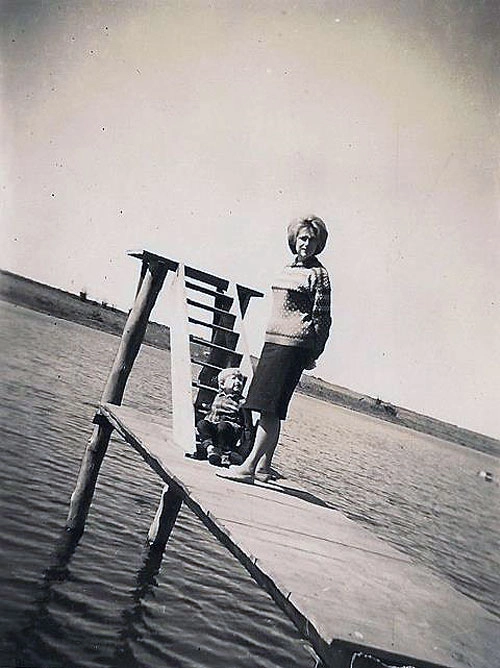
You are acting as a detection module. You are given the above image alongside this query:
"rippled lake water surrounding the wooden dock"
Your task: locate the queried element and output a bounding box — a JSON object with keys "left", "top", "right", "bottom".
{"left": 0, "top": 302, "right": 500, "bottom": 668}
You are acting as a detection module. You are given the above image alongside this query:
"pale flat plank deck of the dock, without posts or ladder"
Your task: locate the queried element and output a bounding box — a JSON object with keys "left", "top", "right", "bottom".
{"left": 101, "top": 404, "right": 500, "bottom": 668}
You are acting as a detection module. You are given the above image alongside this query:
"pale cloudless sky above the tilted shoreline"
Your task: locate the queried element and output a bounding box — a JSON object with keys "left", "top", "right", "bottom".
{"left": 0, "top": 0, "right": 500, "bottom": 438}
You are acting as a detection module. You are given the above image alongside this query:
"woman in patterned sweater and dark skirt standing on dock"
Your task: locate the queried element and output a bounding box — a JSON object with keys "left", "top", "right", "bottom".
{"left": 217, "top": 216, "right": 332, "bottom": 483}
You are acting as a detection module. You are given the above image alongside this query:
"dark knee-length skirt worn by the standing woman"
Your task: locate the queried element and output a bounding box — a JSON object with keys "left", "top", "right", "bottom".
{"left": 245, "top": 343, "right": 311, "bottom": 420}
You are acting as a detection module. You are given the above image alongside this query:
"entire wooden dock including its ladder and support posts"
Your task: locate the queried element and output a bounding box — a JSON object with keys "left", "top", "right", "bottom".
{"left": 62, "top": 251, "right": 500, "bottom": 668}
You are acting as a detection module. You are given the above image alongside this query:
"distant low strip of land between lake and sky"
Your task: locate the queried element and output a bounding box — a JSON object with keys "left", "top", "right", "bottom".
{"left": 0, "top": 269, "right": 500, "bottom": 457}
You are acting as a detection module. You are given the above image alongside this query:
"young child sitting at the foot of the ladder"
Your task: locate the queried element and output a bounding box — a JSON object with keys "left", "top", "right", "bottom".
{"left": 196, "top": 368, "right": 246, "bottom": 466}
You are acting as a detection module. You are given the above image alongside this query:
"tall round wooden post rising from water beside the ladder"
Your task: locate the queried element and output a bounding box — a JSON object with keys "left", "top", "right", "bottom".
{"left": 66, "top": 258, "right": 168, "bottom": 546}
